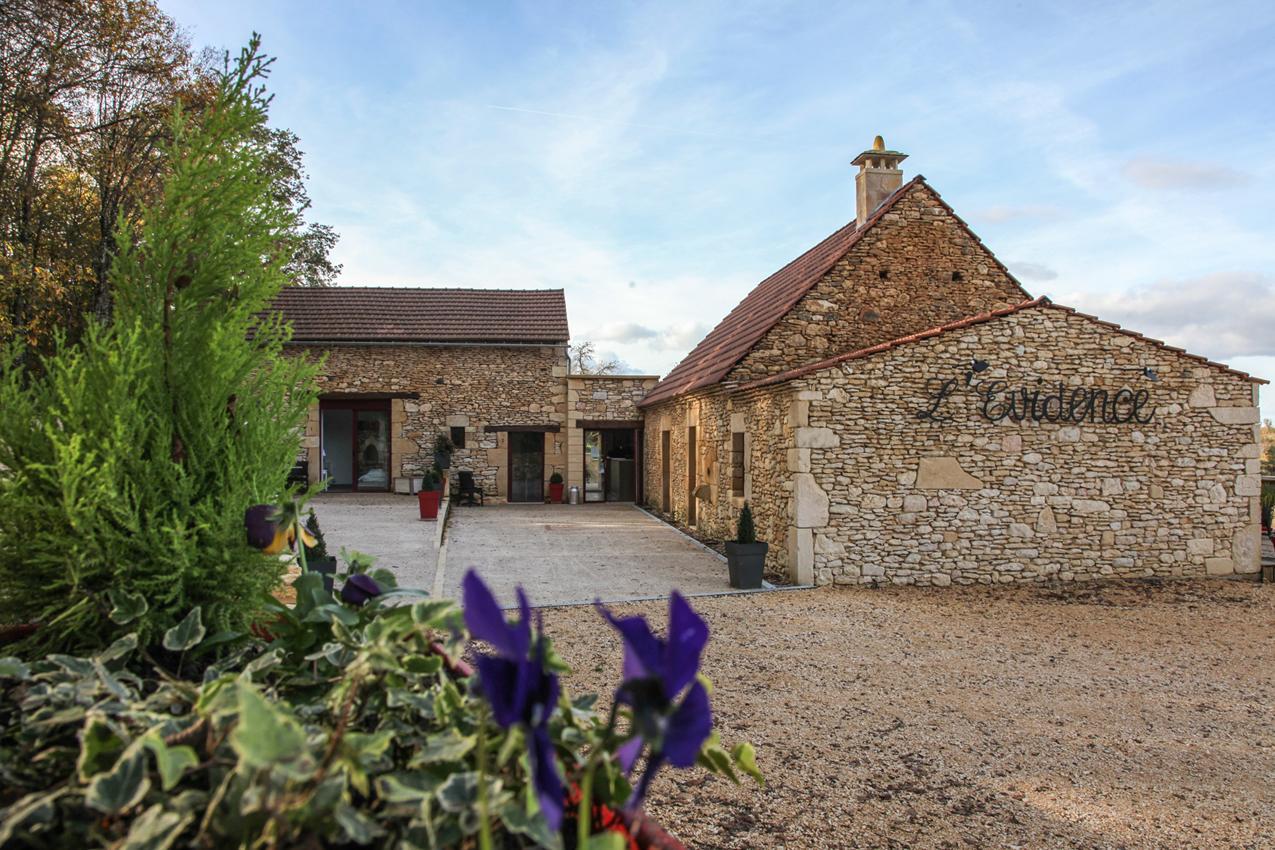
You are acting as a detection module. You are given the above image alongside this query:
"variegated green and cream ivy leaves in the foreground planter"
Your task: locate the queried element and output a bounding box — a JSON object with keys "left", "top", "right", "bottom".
{"left": 0, "top": 586, "right": 760, "bottom": 850}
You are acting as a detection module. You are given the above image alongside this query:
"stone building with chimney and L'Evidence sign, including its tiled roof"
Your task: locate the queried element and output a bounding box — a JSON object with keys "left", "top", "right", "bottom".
{"left": 640, "top": 138, "right": 1264, "bottom": 585}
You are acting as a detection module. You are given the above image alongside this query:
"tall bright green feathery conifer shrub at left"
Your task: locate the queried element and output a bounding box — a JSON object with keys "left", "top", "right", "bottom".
{"left": 0, "top": 42, "right": 317, "bottom": 650}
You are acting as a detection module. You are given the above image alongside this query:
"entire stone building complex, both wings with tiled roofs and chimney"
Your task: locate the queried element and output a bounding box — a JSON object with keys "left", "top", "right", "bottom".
{"left": 278, "top": 136, "right": 1265, "bottom": 586}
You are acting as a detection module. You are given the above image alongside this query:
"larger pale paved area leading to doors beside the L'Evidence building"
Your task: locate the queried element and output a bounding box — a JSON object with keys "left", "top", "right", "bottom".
{"left": 441, "top": 505, "right": 731, "bottom": 605}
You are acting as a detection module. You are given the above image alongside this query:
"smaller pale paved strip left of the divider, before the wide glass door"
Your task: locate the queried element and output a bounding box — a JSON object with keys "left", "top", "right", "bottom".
{"left": 310, "top": 493, "right": 437, "bottom": 590}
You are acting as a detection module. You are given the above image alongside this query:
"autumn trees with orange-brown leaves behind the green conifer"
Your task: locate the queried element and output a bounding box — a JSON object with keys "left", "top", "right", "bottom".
{"left": 0, "top": 0, "right": 339, "bottom": 350}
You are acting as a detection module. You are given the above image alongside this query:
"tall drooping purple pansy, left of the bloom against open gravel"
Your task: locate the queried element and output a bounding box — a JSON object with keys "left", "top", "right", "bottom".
{"left": 462, "top": 570, "right": 564, "bottom": 831}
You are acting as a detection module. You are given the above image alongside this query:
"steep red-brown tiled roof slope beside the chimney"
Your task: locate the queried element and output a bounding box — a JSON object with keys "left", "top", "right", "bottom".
{"left": 639, "top": 175, "right": 1026, "bottom": 407}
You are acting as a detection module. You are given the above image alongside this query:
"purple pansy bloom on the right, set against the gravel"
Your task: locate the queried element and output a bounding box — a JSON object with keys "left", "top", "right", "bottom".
{"left": 598, "top": 590, "right": 713, "bottom": 808}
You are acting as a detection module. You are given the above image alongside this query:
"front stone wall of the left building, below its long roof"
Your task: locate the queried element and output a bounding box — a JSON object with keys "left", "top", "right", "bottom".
{"left": 292, "top": 345, "right": 567, "bottom": 498}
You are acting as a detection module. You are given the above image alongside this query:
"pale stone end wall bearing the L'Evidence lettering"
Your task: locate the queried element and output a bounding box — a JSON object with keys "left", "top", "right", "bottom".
{"left": 791, "top": 307, "right": 1260, "bottom": 585}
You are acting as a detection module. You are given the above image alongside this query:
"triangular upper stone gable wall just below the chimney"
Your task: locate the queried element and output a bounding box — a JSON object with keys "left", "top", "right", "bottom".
{"left": 727, "top": 184, "right": 1029, "bottom": 384}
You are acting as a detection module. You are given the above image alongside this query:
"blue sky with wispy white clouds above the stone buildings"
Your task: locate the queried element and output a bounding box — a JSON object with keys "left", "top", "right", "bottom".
{"left": 161, "top": 0, "right": 1275, "bottom": 418}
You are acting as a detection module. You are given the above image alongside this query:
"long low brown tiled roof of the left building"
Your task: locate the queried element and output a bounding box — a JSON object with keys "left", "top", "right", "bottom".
{"left": 274, "top": 287, "right": 570, "bottom": 343}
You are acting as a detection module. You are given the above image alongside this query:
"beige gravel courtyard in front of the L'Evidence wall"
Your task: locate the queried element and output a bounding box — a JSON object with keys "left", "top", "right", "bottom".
{"left": 546, "top": 581, "right": 1275, "bottom": 849}
